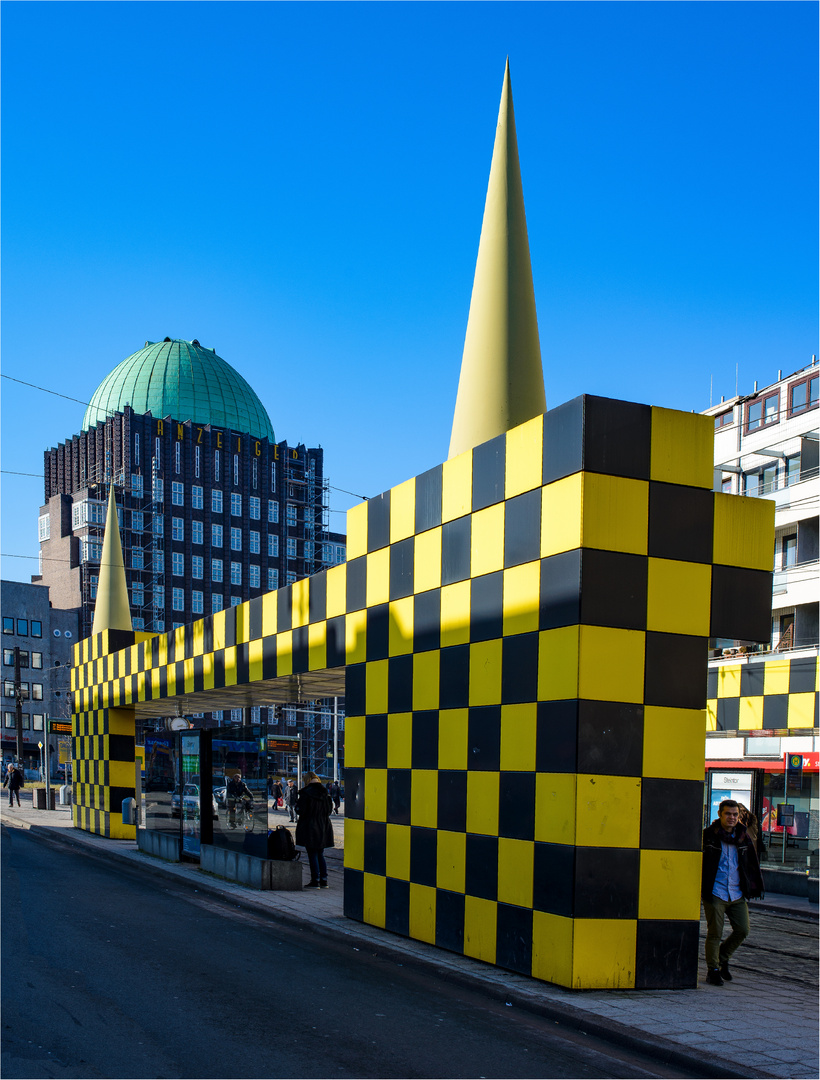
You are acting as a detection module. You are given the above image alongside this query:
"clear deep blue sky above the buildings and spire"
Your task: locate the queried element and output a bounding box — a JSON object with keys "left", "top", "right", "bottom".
{"left": 0, "top": 0, "right": 819, "bottom": 580}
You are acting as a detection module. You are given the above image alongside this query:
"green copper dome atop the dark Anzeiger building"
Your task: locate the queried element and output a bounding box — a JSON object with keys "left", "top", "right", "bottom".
{"left": 82, "top": 338, "right": 273, "bottom": 442}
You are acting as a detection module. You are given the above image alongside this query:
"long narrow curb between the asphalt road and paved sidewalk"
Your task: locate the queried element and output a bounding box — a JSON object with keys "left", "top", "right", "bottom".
{"left": 2, "top": 821, "right": 776, "bottom": 1080}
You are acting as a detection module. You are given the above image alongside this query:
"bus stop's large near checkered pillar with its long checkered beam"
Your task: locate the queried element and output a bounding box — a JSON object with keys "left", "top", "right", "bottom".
{"left": 75, "top": 396, "right": 774, "bottom": 988}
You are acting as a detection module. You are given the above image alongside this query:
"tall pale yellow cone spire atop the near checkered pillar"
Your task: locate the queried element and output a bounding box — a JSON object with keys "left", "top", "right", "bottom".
{"left": 449, "top": 59, "right": 547, "bottom": 458}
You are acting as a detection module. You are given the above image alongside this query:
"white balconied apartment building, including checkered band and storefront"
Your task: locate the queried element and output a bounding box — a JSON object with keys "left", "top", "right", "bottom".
{"left": 705, "top": 356, "right": 820, "bottom": 868}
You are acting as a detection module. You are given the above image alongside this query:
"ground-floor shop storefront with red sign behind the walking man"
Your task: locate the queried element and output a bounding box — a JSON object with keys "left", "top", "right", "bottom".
{"left": 704, "top": 752, "right": 820, "bottom": 873}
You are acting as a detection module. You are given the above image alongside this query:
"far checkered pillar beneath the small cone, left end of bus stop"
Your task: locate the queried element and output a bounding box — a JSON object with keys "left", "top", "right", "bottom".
{"left": 71, "top": 630, "right": 136, "bottom": 840}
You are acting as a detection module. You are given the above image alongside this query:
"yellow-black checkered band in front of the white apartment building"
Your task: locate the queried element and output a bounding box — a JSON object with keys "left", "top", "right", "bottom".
{"left": 707, "top": 653, "right": 820, "bottom": 731}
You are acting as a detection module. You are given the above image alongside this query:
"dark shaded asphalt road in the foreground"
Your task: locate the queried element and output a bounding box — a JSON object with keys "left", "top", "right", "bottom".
{"left": 2, "top": 829, "right": 708, "bottom": 1080}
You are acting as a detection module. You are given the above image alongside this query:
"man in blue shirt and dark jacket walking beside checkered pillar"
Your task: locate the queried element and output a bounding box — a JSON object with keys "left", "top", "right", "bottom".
{"left": 701, "top": 799, "right": 764, "bottom": 986}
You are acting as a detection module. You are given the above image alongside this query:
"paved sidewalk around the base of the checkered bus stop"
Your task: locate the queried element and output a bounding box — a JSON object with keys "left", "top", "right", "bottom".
{"left": 0, "top": 792, "right": 819, "bottom": 1080}
